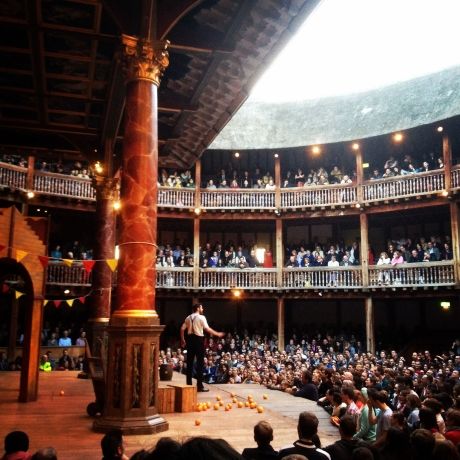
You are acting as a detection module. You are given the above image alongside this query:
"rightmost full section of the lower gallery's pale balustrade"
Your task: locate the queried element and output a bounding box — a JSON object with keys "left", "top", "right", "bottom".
{"left": 369, "top": 260, "right": 455, "bottom": 287}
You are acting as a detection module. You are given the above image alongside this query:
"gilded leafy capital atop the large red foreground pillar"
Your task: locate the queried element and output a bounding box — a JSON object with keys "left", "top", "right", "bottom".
{"left": 121, "top": 34, "right": 169, "bottom": 86}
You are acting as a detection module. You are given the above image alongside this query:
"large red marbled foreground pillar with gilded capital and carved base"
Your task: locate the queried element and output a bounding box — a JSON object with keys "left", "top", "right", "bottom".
{"left": 94, "top": 35, "right": 169, "bottom": 434}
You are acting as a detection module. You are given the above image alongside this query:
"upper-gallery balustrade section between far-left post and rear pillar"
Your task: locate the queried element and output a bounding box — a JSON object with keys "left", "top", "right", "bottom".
{"left": 34, "top": 171, "right": 96, "bottom": 201}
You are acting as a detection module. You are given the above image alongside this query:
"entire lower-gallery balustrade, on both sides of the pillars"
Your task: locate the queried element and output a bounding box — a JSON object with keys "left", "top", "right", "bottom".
{"left": 46, "top": 261, "right": 455, "bottom": 291}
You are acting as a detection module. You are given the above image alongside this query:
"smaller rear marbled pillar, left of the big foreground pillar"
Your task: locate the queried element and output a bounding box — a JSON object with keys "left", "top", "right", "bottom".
{"left": 89, "top": 176, "right": 118, "bottom": 355}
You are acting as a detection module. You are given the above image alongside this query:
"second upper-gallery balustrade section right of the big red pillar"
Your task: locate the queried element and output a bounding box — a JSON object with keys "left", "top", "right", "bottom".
{"left": 200, "top": 189, "right": 275, "bottom": 210}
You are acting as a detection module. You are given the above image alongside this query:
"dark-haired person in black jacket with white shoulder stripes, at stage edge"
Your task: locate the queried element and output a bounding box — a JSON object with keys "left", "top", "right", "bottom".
{"left": 278, "top": 412, "right": 331, "bottom": 460}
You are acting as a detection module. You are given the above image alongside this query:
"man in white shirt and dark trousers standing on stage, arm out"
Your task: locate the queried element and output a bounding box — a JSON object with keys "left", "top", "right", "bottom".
{"left": 180, "top": 303, "right": 225, "bottom": 392}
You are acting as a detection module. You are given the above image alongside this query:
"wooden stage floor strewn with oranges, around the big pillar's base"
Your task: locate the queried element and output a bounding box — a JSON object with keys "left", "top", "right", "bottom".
{"left": 0, "top": 371, "right": 338, "bottom": 460}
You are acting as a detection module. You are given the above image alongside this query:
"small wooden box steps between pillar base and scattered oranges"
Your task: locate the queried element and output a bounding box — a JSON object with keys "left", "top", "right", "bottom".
{"left": 157, "top": 382, "right": 197, "bottom": 414}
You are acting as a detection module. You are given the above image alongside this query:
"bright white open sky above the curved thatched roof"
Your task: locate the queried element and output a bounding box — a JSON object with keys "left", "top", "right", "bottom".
{"left": 249, "top": 0, "right": 460, "bottom": 102}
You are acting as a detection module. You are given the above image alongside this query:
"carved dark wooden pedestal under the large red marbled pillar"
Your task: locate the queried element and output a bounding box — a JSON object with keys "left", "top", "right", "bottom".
{"left": 93, "top": 310, "right": 169, "bottom": 434}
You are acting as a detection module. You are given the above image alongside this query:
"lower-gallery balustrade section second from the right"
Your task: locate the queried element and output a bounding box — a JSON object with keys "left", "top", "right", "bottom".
{"left": 283, "top": 267, "right": 362, "bottom": 289}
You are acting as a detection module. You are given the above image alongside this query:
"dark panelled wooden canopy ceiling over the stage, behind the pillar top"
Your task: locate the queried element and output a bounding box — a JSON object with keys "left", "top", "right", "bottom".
{"left": 0, "top": 0, "right": 319, "bottom": 167}
